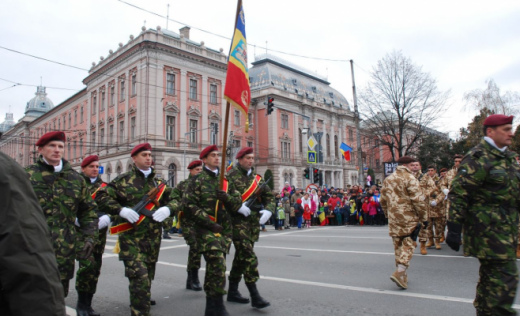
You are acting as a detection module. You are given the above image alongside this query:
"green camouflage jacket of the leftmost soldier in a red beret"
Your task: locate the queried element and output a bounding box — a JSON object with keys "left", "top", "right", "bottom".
{"left": 26, "top": 157, "right": 98, "bottom": 280}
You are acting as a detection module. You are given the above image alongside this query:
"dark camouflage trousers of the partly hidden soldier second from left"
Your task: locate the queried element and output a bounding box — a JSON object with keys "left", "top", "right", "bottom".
{"left": 76, "top": 228, "right": 108, "bottom": 294}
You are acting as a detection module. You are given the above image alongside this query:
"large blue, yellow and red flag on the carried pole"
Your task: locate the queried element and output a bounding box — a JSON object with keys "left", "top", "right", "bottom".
{"left": 224, "top": 0, "right": 251, "bottom": 133}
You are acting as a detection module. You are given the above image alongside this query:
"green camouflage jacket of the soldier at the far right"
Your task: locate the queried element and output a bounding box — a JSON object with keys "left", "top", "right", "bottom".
{"left": 449, "top": 140, "right": 520, "bottom": 260}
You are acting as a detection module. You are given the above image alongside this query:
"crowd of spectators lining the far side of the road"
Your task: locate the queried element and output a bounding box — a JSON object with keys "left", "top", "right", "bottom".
{"left": 262, "top": 182, "right": 388, "bottom": 231}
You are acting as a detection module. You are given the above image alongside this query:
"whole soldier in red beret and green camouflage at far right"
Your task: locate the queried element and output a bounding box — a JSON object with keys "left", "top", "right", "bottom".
{"left": 446, "top": 114, "right": 520, "bottom": 316}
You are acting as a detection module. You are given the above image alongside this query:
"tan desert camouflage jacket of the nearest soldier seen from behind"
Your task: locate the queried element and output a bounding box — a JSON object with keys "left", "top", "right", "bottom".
{"left": 379, "top": 166, "right": 428, "bottom": 237}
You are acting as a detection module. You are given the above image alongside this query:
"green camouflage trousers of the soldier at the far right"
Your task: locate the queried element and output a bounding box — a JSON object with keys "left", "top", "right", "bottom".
{"left": 473, "top": 259, "right": 518, "bottom": 316}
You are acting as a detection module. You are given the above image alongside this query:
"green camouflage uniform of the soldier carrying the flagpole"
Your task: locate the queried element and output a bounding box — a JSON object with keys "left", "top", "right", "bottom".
{"left": 182, "top": 167, "right": 242, "bottom": 297}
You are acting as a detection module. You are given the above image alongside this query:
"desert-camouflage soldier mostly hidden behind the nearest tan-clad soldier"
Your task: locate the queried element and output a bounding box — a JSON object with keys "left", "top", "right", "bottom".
{"left": 411, "top": 161, "right": 437, "bottom": 255}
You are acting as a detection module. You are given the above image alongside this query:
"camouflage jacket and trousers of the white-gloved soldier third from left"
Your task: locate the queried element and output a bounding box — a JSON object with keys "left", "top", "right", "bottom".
{"left": 96, "top": 165, "right": 177, "bottom": 316}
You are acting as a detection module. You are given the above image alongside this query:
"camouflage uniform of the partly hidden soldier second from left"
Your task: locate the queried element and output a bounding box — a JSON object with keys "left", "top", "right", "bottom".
{"left": 76, "top": 175, "right": 108, "bottom": 294}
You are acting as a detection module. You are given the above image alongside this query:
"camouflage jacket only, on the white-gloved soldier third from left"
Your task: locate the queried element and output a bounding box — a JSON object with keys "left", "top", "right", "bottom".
{"left": 96, "top": 165, "right": 178, "bottom": 263}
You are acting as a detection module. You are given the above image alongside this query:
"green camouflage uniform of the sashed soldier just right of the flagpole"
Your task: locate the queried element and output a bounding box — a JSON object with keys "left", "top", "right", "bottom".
{"left": 227, "top": 164, "right": 275, "bottom": 283}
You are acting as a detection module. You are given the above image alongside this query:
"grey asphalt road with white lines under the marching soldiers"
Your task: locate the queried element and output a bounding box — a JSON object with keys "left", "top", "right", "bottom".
{"left": 66, "top": 226, "right": 520, "bottom": 316}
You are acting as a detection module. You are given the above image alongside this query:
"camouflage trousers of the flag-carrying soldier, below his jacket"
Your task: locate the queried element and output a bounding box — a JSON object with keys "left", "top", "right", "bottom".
{"left": 202, "top": 250, "right": 227, "bottom": 297}
